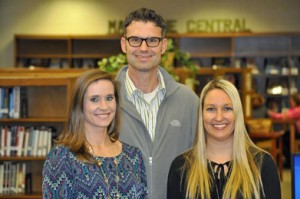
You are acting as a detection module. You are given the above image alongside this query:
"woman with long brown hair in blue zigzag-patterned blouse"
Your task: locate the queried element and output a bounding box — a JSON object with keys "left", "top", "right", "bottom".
{"left": 43, "top": 70, "right": 148, "bottom": 199}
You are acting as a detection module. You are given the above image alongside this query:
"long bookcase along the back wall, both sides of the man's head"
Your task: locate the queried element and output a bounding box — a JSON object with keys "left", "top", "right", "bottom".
{"left": 15, "top": 32, "right": 300, "bottom": 116}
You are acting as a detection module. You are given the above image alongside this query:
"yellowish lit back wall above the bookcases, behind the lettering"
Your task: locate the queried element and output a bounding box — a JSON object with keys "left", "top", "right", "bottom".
{"left": 0, "top": 0, "right": 300, "bottom": 67}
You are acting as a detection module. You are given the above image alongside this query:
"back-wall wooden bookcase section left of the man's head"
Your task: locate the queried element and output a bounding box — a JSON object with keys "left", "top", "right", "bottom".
{"left": 14, "top": 35, "right": 121, "bottom": 68}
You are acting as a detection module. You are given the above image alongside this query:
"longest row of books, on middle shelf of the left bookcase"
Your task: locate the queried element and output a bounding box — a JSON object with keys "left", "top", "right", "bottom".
{"left": 0, "top": 126, "right": 52, "bottom": 157}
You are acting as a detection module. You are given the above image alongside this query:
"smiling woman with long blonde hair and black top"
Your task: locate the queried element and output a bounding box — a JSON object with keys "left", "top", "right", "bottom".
{"left": 167, "top": 79, "right": 281, "bottom": 199}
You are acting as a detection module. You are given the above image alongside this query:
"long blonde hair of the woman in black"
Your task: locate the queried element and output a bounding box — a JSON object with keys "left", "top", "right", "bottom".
{"left": 182, "top": 78, "right": 263, "bottom": 199}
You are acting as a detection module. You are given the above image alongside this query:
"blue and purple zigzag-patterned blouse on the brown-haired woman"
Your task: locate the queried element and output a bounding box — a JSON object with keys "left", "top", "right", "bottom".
{"left": 42, "top": 143, "right": 148, "bottom": 199}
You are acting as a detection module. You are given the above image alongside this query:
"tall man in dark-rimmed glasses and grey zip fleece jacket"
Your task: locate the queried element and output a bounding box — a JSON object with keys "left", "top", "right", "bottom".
{"left": 116, "top": 8, "right": 199, "bottom": 199}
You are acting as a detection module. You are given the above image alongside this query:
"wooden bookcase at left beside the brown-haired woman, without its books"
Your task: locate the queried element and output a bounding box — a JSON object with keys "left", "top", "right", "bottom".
{"left": 0, "top": 69, "right": 84, "bottom": 199}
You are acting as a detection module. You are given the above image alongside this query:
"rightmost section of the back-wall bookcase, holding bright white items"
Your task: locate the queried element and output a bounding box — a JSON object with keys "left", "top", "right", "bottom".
{"left": 235, "top": 33, "right": 300, "bottom": 112}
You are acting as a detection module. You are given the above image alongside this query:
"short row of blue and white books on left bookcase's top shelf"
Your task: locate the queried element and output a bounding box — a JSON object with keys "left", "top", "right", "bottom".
{"left": 0, "top": 86, "right": 28, "bottom": 118}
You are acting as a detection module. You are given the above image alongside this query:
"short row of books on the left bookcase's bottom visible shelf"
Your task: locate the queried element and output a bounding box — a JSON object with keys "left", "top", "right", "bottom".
{"left": 0, "top": 161, "right": 26, "bottom": 194}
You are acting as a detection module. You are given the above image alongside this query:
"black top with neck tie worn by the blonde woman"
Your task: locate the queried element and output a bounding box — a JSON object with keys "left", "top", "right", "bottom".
{"left": 167, "top": 153, "right": 281, "bottom": 199}
